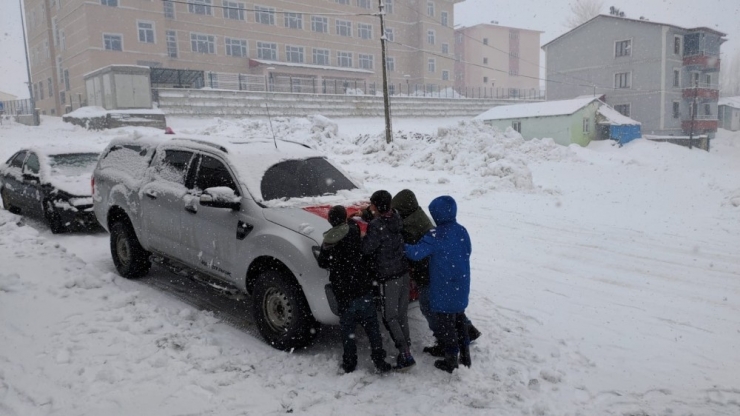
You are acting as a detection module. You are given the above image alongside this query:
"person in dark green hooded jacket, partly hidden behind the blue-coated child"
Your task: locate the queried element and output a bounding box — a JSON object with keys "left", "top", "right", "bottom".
{"left": 391, "top": 189, "right": 481, "bottom": 357}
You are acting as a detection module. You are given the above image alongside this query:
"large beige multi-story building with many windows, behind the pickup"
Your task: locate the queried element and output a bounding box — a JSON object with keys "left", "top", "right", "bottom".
{"left": 24, "top": 0, "right": 462, "bottom": 114}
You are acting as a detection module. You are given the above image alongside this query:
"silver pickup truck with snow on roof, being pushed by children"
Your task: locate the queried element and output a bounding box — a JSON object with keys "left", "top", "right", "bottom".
{"left": 92, "top": 136, "right": 367, "bottom": 350}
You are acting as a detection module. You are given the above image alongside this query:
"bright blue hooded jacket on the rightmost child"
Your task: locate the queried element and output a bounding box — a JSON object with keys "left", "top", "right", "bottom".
{"left": 406, "top": 196, "right": 472, "bottom": 313}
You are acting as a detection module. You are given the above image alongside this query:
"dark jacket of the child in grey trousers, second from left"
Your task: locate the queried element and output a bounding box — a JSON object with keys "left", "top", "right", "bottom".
{"left": 362, "top": 210, "right": 409, "bottom": 283}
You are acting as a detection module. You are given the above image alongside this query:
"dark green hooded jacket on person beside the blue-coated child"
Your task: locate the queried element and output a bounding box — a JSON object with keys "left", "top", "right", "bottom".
{"left": 391, "top": 189, "right": 434, "bottom": 286}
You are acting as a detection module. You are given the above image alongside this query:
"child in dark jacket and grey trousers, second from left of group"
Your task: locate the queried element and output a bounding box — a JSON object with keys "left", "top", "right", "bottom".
{"left": 362, "top": 190, "right": 416, "bottom": 370}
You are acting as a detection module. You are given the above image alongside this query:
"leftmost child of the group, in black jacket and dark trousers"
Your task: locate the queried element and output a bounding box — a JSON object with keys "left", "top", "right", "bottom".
{"left": 318, "top": 205, "right": 391, "bottom": 373}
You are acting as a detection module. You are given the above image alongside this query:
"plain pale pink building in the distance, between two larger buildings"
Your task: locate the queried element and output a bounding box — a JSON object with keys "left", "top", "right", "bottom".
{"left": 455, "top": 24, "right": 542, "bottom": 96}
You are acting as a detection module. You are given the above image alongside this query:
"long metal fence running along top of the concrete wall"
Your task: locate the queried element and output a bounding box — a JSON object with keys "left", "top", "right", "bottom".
{"left": 202, "top": 72, "right": 545, "bottom": 100}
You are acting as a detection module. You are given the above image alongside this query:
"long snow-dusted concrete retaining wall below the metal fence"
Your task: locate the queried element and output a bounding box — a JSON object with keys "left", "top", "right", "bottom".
{"left": 155, "top": 88, "right": 540, "bottom": 117}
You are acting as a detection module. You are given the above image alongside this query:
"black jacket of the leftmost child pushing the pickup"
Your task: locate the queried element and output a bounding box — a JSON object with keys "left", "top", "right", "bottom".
{"left": 318, "top": 221, "right": 372, "bottom": 311}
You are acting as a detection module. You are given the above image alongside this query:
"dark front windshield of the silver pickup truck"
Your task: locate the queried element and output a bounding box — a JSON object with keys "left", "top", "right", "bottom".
{"left": 261, "top": 157, "right": 357, "bottom": 201}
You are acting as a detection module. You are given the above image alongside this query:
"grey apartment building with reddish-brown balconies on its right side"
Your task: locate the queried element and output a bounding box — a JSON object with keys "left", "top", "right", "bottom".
{"left": 542, "top": 15, "right": 726, "bottom": 137}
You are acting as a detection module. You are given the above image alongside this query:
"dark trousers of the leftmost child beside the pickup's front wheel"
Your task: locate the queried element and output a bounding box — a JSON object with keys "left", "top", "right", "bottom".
{"left": 339, "top": 294, "right": 385, "bottom": 367}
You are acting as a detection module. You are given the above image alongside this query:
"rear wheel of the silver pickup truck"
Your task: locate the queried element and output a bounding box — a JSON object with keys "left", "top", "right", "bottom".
{"left": 110, "top": 221, "right": 152, "bottom": 279}
